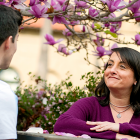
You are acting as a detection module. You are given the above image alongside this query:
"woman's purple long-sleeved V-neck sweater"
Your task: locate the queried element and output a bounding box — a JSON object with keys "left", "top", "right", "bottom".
{"left": 54, "top": 96, "right": 140, "bottom": 139}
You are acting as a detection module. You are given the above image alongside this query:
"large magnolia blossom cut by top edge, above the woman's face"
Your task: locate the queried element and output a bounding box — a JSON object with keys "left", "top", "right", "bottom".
{"left": 101, "top": 0, "right": 126, "bottom": 12}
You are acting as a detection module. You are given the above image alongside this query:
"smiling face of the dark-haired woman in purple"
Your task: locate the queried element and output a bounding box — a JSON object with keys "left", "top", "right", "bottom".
{"left": 104, "top": 52, "right": 136, "bottom": 90}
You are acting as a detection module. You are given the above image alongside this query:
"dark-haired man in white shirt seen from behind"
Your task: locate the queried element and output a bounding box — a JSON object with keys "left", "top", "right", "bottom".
{"left": 0, "top": 5, "right": 22, "bottom": 140}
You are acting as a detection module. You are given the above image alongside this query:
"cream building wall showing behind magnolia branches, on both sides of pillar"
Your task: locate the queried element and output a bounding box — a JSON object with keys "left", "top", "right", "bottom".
{"left": 5, "top": 19, "right": 140, "bottom": 89}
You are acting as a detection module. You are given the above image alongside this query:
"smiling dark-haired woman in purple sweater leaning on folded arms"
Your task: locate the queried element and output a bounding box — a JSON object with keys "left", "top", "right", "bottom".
{"left": 54, "top": 47, "right": 140, "bottom": 140}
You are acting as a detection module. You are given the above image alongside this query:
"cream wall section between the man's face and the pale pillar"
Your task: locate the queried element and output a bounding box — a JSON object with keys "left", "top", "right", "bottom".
{"left": 10, "top": 29, "right": 41, "bottom": 87}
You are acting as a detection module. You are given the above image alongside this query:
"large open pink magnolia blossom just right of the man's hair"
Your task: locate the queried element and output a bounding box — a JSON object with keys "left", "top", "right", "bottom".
{"left": 29, "top": 4, "right": 48, "bottom": 18}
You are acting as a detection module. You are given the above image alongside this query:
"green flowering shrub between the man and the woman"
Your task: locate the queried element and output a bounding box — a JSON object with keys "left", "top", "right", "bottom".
{"left": 16, "top": 72, "right": 102, "bottom": 133}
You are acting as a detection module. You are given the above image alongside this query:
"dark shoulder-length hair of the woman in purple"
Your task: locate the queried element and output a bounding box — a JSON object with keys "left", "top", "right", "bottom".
{"left": 95, "top": 47, "right": 140, "bottom": 115}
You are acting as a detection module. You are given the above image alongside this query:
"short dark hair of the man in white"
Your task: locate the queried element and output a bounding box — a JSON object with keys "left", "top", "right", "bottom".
{"left": 0, "top": 5, "right": 22, "bottom": 46}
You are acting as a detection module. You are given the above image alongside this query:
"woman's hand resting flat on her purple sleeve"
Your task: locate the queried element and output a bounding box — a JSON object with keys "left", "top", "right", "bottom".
{"left": 86, "top": 121, "right": 120, "bottom": 133}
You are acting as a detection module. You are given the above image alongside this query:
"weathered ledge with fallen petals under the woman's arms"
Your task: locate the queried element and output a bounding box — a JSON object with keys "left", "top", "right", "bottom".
{"left": 17, "top": 131, "right": 105, "bottom": 140}
